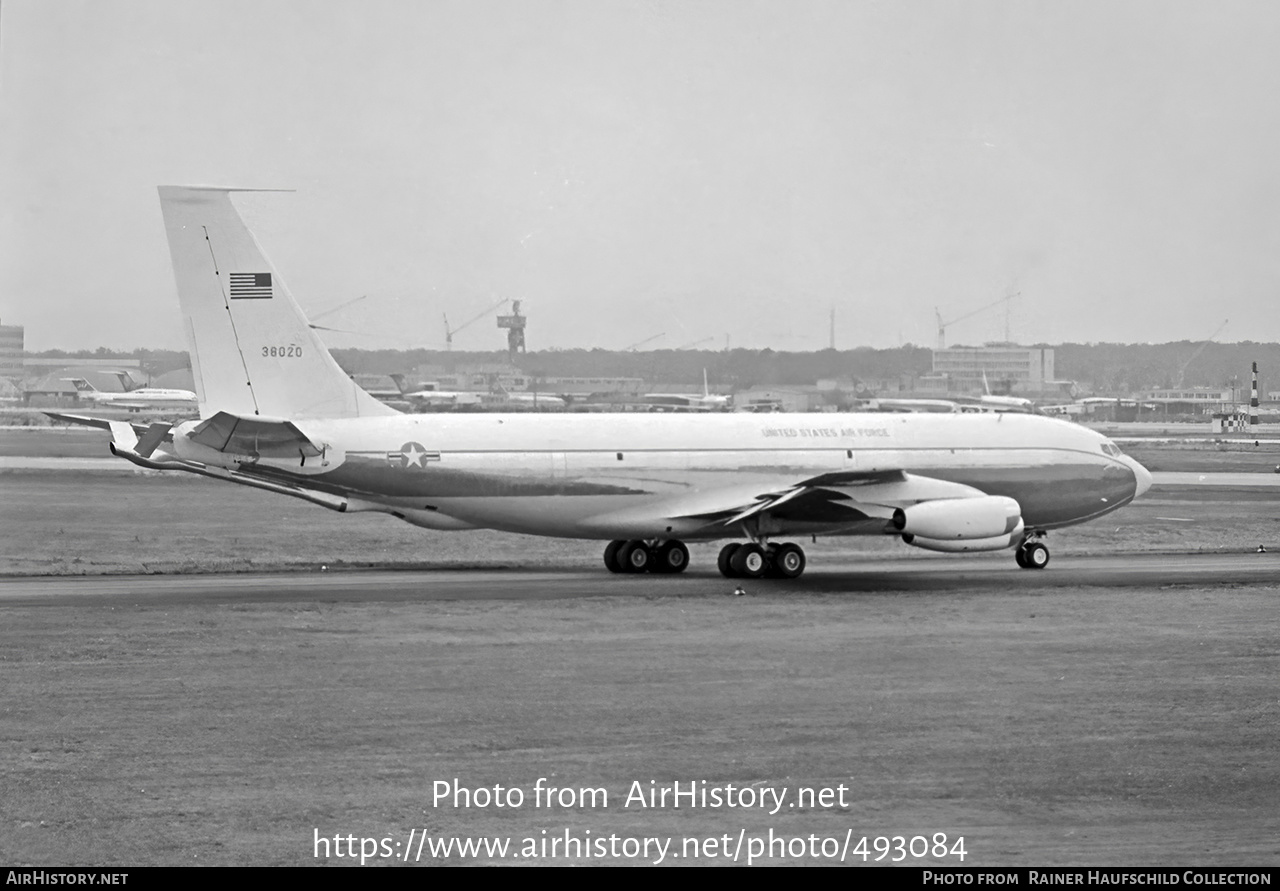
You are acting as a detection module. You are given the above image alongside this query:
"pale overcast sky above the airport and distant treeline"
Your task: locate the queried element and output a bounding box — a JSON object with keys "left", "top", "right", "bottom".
{"left": 0, "top": 0, "right": 1280, "bottom": 351}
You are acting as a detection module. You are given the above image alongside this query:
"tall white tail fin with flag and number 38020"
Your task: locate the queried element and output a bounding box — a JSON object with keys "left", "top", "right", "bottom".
{"left": 160, "top": 186, "right": 397, "bottom": 419}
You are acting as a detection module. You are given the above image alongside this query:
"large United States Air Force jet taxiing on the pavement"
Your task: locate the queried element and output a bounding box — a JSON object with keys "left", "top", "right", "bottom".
{"left": 49, "top": 186, "right": 1151, "bottom": 579}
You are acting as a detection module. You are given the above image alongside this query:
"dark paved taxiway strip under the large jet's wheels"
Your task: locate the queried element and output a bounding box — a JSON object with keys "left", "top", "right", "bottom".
{"left": 0, "top": 552, "right": 1280, "bottom": 606}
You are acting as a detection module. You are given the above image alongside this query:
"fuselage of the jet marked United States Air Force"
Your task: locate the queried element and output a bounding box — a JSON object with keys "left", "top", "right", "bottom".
{"left": 167, "top": 413, "right": 1149, "bottom": 538}
